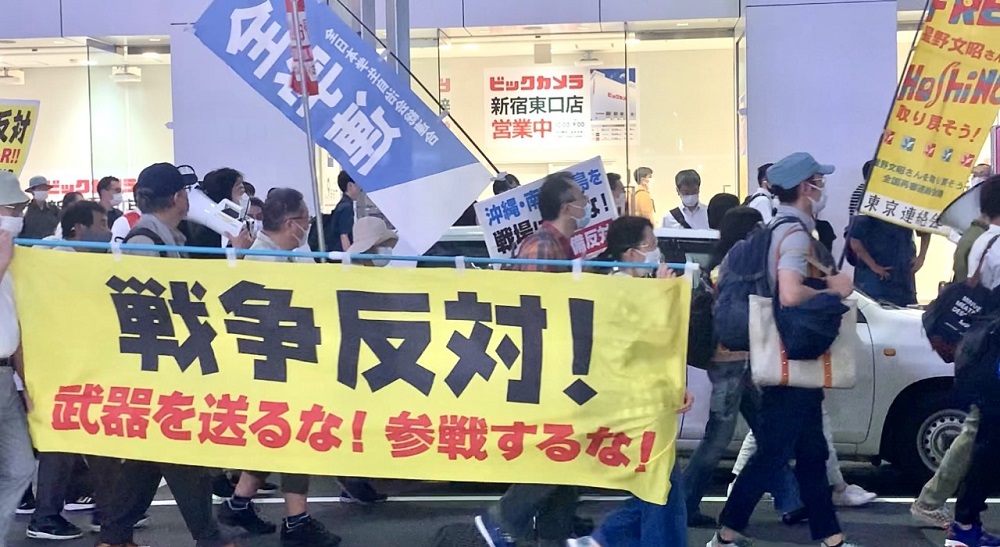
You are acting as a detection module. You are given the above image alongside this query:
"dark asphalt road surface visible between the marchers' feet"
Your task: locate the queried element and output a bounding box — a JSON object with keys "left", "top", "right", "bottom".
{"left": 1, "top": 464, "right": 984, "bottom": 547}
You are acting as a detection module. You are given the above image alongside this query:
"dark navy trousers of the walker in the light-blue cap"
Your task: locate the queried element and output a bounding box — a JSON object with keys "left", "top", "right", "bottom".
{"left": 719, "top": 387, "right": 840, "bottom": 540}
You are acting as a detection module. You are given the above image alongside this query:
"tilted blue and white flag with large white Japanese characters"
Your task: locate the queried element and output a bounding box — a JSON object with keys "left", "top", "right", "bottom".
{"left": 195, "top": 0, "right": 490, "bottom": 254}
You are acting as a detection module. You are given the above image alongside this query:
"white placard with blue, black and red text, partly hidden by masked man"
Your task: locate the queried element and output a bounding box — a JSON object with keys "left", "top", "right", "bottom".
{"left": 476, "top": 157, "right": 618, "bottom": 258}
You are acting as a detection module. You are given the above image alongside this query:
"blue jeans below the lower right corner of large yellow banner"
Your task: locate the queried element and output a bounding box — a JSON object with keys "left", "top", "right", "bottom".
{"left": 593, "top": 465, "right": 688, "bottom": 547}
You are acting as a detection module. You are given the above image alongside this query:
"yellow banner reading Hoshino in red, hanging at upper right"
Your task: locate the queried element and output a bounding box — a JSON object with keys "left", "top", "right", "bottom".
{"left": 861, "top": 0, "right": 1000, "bottom": 233}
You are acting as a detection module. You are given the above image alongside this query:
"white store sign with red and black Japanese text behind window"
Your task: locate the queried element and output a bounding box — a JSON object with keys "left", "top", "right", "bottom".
{"left": 484, "top": 66, "right": 639, "bottom": 147}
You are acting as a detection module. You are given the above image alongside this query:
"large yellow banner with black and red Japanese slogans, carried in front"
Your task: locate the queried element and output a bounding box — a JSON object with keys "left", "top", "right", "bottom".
{"left": 12, "top": 248, "right": 691, "bottom": 503}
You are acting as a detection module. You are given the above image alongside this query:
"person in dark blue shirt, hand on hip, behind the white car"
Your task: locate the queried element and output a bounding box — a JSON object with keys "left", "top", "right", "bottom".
{"left": 852, "top": 185, "right": 930, "bottom": 306}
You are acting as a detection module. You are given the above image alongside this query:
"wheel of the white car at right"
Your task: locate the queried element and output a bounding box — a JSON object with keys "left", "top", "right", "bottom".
{"left": 895, "top": 393, "right": 966, "bottom": 484}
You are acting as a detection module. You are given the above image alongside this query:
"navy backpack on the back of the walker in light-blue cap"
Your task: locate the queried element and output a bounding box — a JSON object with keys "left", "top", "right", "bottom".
{"left": 712, "top": 217, "right": 804, "bottom": 351}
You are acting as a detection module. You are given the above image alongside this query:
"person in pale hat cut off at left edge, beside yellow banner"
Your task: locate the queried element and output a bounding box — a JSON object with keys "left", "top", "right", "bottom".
{"left": 0, "top": 174, "right": 35, "bottom": 539}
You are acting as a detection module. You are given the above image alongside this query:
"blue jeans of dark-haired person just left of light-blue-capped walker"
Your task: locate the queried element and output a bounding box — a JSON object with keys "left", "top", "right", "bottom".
{"left": 684, "top": 361, "right": 802, "bottom": 515}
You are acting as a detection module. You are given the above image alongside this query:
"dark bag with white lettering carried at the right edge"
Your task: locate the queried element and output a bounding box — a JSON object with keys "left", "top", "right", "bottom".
{"left": 921, "top": 236, "right": 1000, "bottom": 363}
